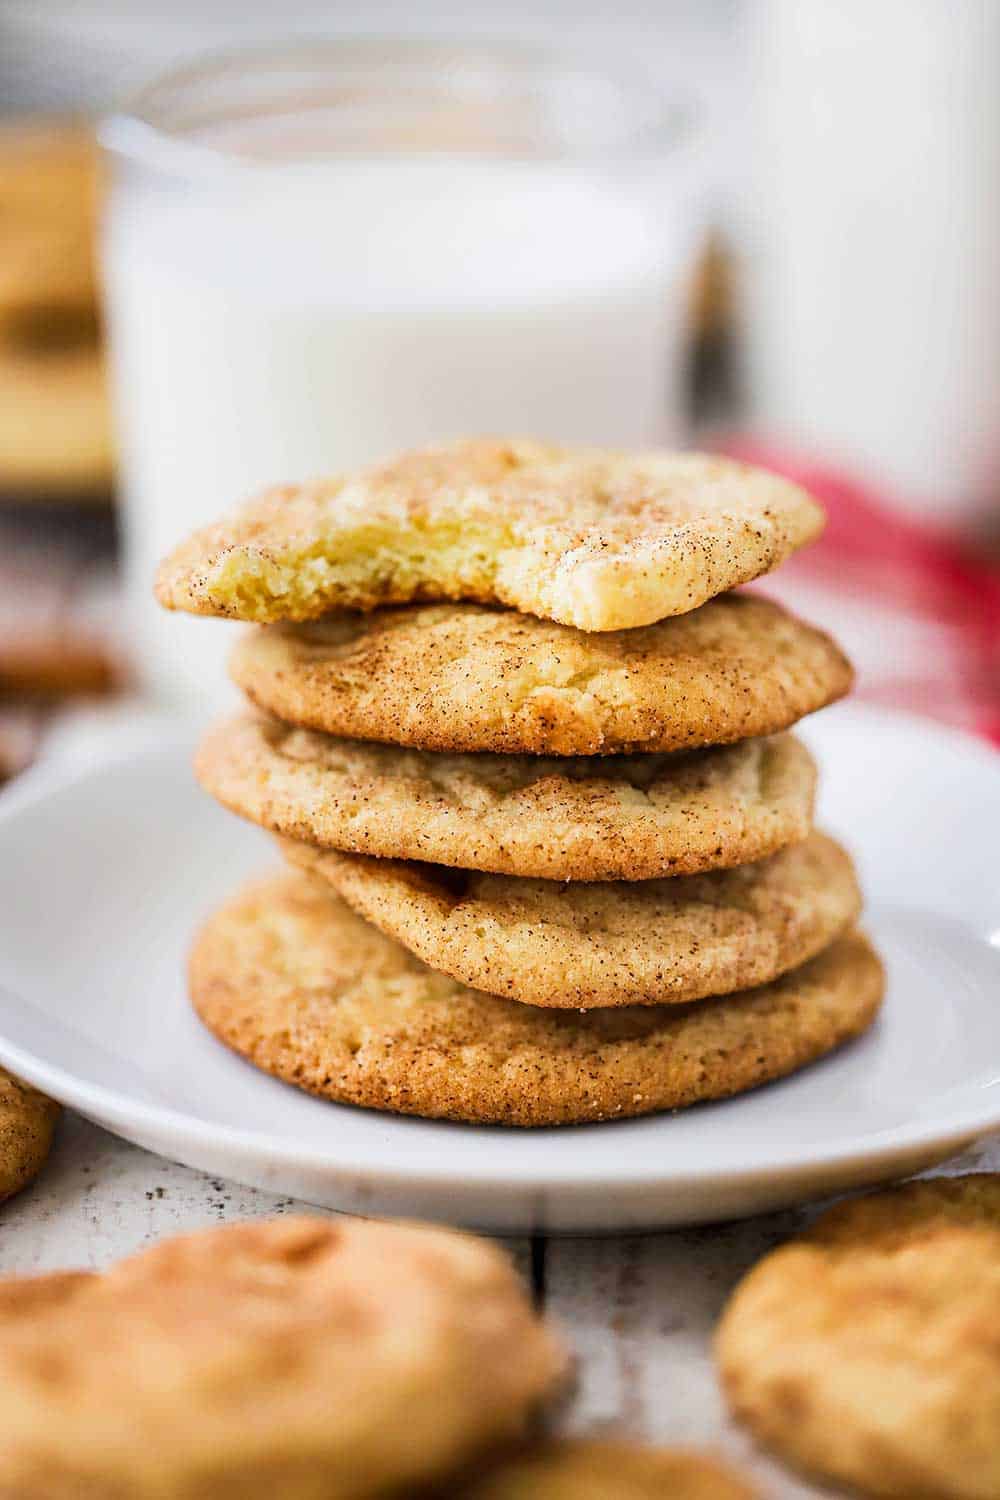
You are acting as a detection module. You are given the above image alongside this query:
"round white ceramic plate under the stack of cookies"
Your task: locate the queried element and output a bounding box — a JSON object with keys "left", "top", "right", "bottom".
{"left": 0, "top": 707, "right": 1000, "bottom": 1232}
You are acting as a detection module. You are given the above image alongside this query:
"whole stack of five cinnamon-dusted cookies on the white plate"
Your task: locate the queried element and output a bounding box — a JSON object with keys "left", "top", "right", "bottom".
{"left": 157, "top": 441, "right": 883, "bottom": 1125}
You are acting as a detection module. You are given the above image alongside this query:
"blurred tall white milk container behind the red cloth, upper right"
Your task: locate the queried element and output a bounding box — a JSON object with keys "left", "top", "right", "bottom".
{"left": 744, "top": 0, "right": 1000, "bottom": 527}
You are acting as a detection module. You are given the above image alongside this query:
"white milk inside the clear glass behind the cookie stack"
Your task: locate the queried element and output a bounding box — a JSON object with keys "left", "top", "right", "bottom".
{"left": 105, "top": 49, "right": 693, "bottom": 699}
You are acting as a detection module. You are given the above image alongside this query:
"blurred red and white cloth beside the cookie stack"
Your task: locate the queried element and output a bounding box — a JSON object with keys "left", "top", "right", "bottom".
{"left": 724, "top": 440, "right": 1000, "bottom": 744}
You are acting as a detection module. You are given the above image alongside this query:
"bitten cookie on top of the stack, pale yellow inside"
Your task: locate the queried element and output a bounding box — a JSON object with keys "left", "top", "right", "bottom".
{"left": 156, "top": 438, "right": 825, "bottom": 630}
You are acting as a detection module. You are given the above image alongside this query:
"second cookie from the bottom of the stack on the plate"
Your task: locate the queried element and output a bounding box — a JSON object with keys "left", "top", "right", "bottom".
{"left": 282, "top": 833, "right": 861, "bottom": 1010}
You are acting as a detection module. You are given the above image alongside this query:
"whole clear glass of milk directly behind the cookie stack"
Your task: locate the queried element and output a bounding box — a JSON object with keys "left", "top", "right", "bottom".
{"left": 103, "top": 42, "right": 699, "bottom": 702}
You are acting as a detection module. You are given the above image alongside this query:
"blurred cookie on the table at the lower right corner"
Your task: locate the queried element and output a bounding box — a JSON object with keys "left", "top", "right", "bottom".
{"left": 717, "top": 1173, "right": 1000, "bottom": 1500}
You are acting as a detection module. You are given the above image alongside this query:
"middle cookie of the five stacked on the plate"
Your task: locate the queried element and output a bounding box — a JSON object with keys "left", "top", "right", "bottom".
{"left": 195, "top": 714, "right": 816, "bottom": 881}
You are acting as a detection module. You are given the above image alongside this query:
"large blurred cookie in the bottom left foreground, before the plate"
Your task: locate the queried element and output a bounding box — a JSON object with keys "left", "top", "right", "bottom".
{"left": 0, "top": 1218, "right": 565, "bottom": 1500}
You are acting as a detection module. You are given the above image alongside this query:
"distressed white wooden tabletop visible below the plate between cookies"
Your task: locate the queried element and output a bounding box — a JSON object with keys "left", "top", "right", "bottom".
{"left": 0, "top": 1113, "right": 1000, "bottom": 1500}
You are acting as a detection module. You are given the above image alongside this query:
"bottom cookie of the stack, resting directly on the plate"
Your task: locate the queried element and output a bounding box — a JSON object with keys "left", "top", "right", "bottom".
{"left": 189, "top": 873, "right": 883, "bottom": 1125}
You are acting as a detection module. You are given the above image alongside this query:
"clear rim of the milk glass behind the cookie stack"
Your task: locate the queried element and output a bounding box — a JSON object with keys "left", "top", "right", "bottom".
{"left": 97, "top": 36, "right": 702, "bottom": 174}
